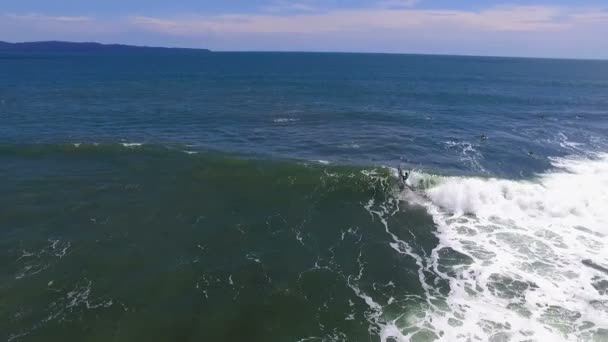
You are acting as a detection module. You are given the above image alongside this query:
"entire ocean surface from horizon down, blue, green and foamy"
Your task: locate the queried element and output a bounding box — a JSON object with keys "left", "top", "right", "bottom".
{"left": 0, "top": 51, "right": 608, "bottom": 342}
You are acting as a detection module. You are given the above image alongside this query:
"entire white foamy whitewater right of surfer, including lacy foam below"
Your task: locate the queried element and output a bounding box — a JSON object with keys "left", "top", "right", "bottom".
{"left": 414, "top": 155, "right": 608, "bottom": 341}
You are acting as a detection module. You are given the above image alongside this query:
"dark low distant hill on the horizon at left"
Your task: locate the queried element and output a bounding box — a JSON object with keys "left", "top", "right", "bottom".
{"left": 0, "top": 41, "right": 211, "bottom": 53}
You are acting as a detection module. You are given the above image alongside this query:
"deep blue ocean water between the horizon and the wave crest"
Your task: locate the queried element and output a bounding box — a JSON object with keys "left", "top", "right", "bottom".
{"left": 0, "top": 53, "right": 608, "bottom": 177}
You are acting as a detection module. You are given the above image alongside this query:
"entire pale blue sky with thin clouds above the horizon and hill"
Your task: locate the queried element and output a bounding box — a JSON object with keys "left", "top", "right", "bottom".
{"left": 0, "top": 0, "right": 608, "bottom": 59}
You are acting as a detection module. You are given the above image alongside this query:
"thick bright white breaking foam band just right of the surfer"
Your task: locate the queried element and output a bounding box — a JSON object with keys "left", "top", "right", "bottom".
{"left": 426, "top": 155, "right": 608, "bottom": 234}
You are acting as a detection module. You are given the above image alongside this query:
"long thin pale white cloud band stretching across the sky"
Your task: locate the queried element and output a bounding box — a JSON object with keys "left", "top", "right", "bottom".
{"left": 130, "top": 6, "right": 582, "bottom": 35}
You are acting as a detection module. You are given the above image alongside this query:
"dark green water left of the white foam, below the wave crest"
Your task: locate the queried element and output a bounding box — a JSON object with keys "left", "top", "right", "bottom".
{"left": 0, "top": 145, "right": 437, "bottom": 341}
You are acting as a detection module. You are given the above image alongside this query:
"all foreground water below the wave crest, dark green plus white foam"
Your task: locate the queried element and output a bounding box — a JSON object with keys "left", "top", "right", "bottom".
{"left": 0, "top": 143, "right": 608, "bottom": 341}
